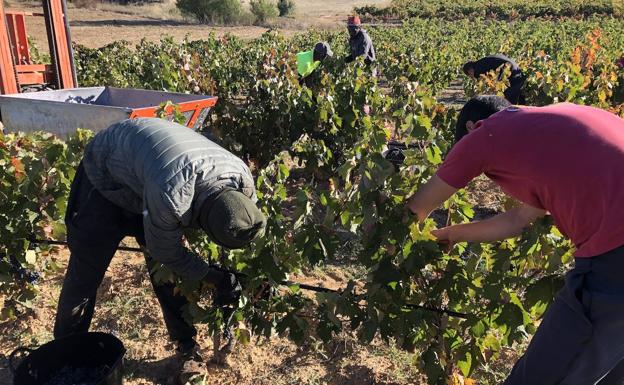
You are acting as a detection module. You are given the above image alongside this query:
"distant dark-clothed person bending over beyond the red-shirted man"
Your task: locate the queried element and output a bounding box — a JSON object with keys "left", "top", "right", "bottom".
{"left": 462, "top": 54, "right": 526, "bottom": 104}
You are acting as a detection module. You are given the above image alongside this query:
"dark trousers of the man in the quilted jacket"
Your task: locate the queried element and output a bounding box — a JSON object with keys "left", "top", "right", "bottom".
{"left": 54, "top": 165, "right": 196, "bottom": 341}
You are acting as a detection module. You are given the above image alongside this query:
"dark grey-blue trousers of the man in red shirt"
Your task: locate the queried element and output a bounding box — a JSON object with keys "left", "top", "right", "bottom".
{"left": 504, "top": 246, "right": 624, "bottom": 385}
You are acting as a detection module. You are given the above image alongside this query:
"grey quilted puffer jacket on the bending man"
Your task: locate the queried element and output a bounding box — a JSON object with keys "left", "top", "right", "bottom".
{"left": 83, "top": 118, "right": 256, "bottom": 279}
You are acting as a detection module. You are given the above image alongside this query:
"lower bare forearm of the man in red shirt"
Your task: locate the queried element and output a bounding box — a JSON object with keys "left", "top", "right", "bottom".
{"left": 432, "top": 204, "right": 546, "bottom": 245}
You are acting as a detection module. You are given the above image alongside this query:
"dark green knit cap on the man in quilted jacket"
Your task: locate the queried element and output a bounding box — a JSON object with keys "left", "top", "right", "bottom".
{"left": 199, "top": 190, "right": 266, "bottom": 249}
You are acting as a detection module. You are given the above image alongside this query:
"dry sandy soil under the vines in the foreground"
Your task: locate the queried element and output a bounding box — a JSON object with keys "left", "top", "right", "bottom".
{"left": 0, "top": 244, "right": 420, "bottom": 385}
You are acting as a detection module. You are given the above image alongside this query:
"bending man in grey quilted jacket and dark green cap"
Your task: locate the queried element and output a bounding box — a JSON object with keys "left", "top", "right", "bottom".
{"left": 54, "top": 118, "right": 266, "bottom": 379}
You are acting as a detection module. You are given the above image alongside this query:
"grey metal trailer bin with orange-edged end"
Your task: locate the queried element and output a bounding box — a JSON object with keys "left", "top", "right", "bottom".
{"left": 0, "top": 87, "right": 217, "bottom": 137}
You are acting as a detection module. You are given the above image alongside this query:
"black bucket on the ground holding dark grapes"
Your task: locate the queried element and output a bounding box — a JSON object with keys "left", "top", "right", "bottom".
{"left": 9, "top": 332, "right": 126, "bottom": 385}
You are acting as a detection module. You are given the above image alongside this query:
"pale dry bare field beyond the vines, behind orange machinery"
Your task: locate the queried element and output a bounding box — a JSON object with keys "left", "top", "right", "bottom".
{"left": 8, "top": 0, "right": 387, "bottom": 50}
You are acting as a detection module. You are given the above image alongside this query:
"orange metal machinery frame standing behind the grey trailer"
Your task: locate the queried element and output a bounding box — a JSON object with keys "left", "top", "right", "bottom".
{"left": 0, "top": 0, "right": 78, "bottom": 94}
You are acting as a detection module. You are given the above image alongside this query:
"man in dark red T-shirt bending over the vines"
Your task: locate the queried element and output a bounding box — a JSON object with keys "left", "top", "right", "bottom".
{"left": 407, "top": 96, "right": 624, "bottom": 385}
